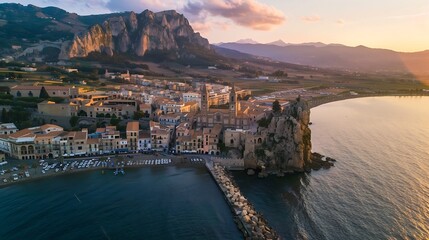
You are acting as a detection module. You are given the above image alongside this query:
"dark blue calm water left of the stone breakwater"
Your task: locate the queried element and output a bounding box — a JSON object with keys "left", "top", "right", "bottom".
{"left": 0, "top": 166, "right": 242, "bottom": 240}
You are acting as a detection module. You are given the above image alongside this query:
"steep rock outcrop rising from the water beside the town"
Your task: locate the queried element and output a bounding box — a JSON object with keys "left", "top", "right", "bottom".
{"left": 245, "top": 99, "right": 312, "bottom": 171}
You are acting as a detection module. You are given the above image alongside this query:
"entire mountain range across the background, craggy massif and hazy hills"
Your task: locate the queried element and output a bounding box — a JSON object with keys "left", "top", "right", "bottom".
{"left": 0, "top": 3, "right": 429, "bottom": 73}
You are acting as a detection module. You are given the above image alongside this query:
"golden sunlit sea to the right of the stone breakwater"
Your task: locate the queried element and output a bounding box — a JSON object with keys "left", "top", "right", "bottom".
{"left": 234, "top": 97, "right": 429, "bottom": 240}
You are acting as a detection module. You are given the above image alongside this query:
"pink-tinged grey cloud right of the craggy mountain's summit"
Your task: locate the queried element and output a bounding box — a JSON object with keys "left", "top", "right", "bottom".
{"left": 183, "top": 0, "right": 286, "bottom": 30}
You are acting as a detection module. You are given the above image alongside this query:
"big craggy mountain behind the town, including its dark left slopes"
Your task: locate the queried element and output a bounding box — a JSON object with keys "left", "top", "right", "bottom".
{"left": 0, "top": 4, "right": 212, "bottom": 62}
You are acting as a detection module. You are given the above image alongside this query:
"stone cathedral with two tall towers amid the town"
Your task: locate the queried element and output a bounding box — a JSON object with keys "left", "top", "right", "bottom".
{"left": 196, "top": 84, "right": 252, "bottom": 129}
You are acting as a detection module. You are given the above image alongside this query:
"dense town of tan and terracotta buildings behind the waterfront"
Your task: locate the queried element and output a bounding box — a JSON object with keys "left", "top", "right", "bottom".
{"left": 0, "top": 79, "right": 285, "bottom": 160}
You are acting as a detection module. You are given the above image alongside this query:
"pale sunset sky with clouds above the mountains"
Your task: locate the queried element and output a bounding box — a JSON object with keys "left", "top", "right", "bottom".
{"left": 0, "top": 0, "right": 429, "bottom": 52}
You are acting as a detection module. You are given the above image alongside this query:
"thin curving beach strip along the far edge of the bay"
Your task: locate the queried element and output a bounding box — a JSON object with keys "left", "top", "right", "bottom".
{"left": 307, "top": 93, "right": 429, "bottom": 109}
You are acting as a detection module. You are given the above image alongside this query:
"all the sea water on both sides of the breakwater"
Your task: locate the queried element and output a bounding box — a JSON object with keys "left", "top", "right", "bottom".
{"left": 0, "top": 97, "right": 429, "bottom": 240}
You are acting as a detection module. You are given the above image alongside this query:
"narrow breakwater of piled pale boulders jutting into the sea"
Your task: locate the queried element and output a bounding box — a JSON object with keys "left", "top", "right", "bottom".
{"left": 206, "top": 161, "right": 280, "bottom": 239}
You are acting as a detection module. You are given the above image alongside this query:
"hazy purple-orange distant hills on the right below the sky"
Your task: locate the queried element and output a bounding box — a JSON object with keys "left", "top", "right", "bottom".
{"left": 219, "top": 43, "right": 429, "bottom": 73}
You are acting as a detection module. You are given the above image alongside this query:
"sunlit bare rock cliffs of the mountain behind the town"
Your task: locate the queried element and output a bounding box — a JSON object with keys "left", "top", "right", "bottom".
{"left": 62, "top": 10, "right": 210, "bottom": 58}
